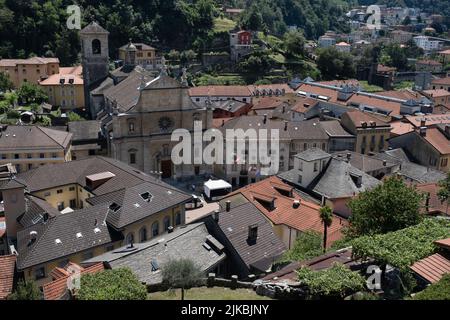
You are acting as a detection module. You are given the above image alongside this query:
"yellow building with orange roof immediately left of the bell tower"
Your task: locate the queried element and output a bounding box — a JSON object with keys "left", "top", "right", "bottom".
{"left": 39, "top": 66, "right": 85, "bottom": 111}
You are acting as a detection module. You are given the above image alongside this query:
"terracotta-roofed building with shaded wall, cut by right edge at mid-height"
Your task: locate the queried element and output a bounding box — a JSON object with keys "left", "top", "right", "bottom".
{"left": 389, "top": 124, "right": 450, "bottom": 172}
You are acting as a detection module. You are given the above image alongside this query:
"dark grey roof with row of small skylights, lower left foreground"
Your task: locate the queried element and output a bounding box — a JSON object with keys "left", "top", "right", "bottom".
{"left": 17, "top": 205, "right": 121, "bottom": 269}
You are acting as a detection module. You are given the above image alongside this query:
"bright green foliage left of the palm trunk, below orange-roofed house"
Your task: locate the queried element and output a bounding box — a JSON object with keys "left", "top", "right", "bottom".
{"left": 281, "top": 231, "right": 322, "bottom": 262}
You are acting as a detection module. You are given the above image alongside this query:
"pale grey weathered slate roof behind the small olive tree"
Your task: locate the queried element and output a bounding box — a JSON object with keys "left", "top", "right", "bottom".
{"left": 83, "top": 223, "right": 226, "bottom": 284}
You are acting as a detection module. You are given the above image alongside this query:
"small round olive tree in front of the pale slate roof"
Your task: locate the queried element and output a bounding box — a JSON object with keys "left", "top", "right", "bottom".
{"left": 162, "top": 259, "right": 202, "bottom": 300}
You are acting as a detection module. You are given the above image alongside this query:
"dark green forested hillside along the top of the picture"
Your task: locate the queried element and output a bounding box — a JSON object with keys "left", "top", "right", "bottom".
{"left": 0, "top": 0, "right": 450, "bottom": 65}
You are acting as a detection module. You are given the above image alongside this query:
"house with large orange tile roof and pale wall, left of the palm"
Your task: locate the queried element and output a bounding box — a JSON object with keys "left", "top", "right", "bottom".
{"left": 229, "top": 176, "right": 348, "bottom": 249}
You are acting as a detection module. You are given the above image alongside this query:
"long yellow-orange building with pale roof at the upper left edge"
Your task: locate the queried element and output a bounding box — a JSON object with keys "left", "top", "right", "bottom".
{"left": 0, "top": 57, "right": 59, "bottom": 88}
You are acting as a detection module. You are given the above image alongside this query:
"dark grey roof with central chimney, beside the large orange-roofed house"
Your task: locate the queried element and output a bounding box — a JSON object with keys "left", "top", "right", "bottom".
{"left": 214, "top": 198, "right": 286, "bottom": 271}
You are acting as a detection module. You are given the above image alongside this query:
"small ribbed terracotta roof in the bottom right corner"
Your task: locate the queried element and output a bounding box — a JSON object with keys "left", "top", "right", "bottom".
{"left": 410, "top": 253, "right": 450, "bottom": 283}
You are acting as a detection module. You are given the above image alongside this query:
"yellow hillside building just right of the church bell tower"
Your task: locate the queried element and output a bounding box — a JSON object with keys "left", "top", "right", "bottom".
{"left": 119, "top": 41, "right": 162, "bottom": 70}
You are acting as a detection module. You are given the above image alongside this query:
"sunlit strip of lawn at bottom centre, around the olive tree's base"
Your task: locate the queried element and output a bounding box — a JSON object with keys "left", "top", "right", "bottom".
{"left": 148, "top": 287, "right": 271, "bottom": 300}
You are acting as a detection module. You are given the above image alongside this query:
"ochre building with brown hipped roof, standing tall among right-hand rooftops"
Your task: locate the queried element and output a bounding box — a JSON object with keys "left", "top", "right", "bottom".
{"left": 341, "top": 110, "right": 391, "bottom": 154}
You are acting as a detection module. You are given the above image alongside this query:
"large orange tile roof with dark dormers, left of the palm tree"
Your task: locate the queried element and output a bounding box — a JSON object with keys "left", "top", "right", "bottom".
{"left": 233, "top": 176, "right": 347, "bottom": 245}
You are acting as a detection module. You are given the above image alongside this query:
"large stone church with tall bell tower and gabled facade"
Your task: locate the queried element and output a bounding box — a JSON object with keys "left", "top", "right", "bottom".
{"left": 80, "top": 22, "right": 213, "bottom": 180}
